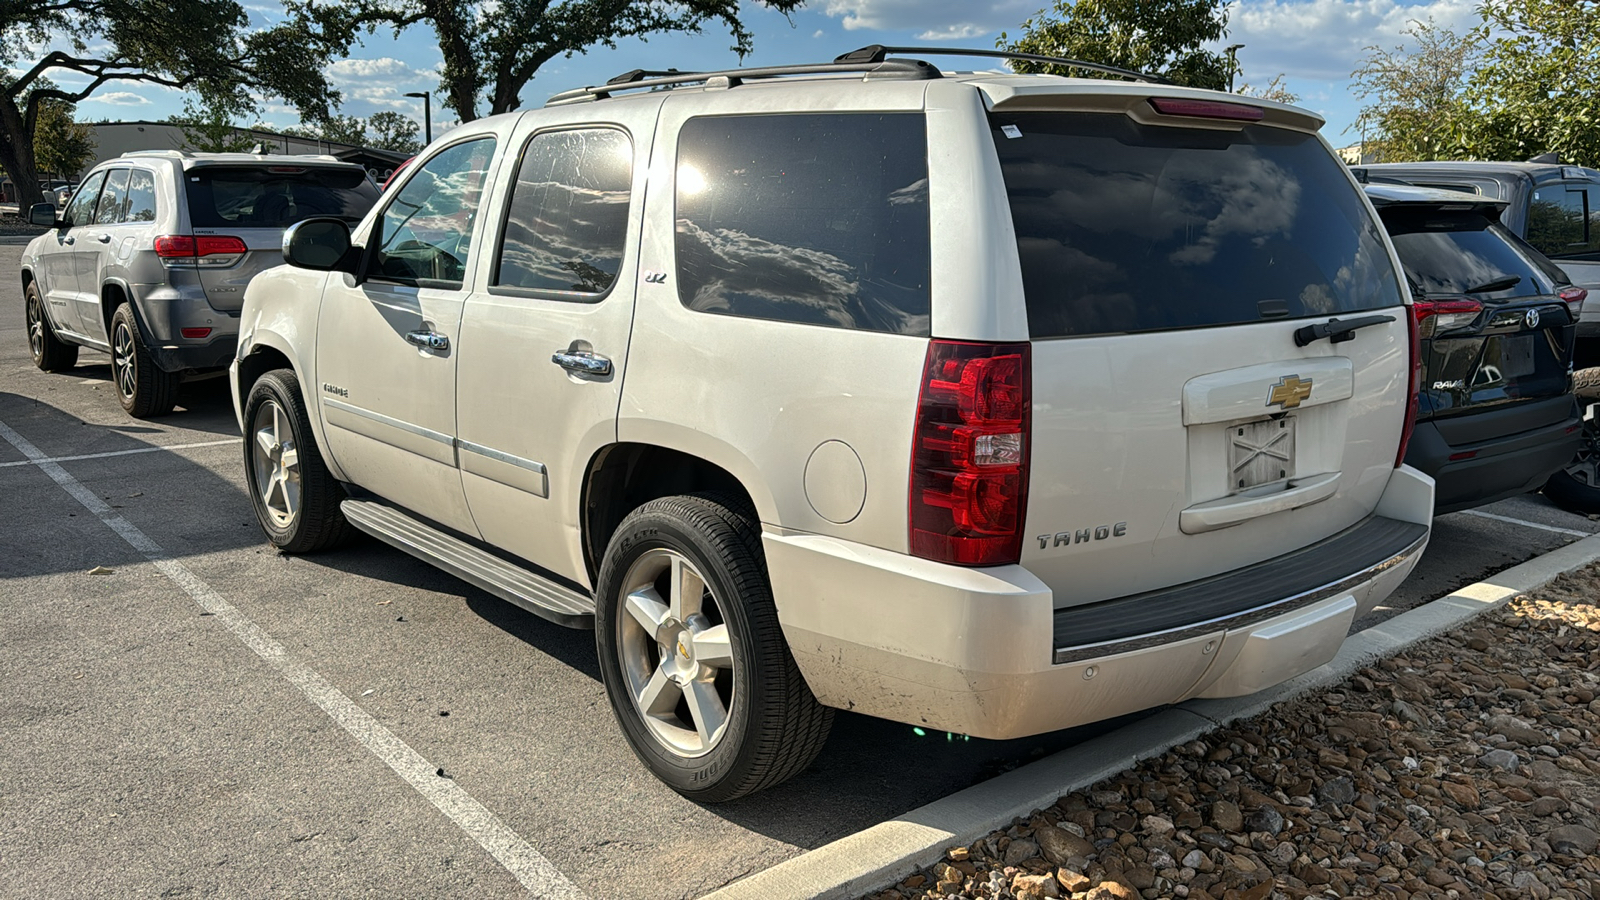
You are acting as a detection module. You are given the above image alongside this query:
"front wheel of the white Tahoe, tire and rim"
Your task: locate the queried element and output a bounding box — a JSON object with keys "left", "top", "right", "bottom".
{"left": 245, "top": 368, "right": 354, "bottom": 552}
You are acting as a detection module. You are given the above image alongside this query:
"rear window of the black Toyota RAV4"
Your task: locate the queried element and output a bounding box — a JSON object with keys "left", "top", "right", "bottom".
{"left": 1382, "top": 208, "right": 1554, "bottom": 299}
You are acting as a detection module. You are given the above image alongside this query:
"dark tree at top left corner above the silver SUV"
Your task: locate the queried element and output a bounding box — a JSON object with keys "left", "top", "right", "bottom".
{"left": 0, "top": 0, "right": 336, "bottom": 200}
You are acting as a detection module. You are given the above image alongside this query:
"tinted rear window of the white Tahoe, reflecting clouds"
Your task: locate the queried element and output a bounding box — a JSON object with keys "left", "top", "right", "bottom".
{"left": 992, "top": 112, "right": 1400, "bottom": 338}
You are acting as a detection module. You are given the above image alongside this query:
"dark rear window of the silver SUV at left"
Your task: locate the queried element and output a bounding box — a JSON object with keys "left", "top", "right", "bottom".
{"left": 184, "top": 160, "right": 378, "bottom": 227}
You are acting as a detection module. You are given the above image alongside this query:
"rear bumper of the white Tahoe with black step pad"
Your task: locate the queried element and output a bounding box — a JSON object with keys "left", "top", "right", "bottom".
{"left": 763, "top": 468, "right": 1434, "bottom": 738}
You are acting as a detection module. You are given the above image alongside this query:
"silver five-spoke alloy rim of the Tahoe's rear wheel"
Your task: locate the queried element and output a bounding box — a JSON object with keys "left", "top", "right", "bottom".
{"left": 616, "top": 548, "right": 734, "bottom": 759}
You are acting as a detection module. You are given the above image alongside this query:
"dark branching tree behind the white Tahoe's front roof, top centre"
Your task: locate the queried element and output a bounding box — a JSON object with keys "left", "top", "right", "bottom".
{"left": 288, "top": 0, "right": 805, "bottom": 122}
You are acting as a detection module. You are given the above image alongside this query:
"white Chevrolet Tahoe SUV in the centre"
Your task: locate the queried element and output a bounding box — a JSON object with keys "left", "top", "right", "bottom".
{"left": 232, "top": 48, "right": 1434, "bottom": 801}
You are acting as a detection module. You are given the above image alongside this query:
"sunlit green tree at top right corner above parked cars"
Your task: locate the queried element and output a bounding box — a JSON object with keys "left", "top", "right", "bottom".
{"left": 1352, "top": 0, "right": 1600, "bottom": 167}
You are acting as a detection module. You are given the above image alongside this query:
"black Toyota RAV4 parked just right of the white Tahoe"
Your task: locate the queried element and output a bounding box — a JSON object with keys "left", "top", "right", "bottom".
{"left": 1366, "top": 184, "right": 1587, "bottom": 512}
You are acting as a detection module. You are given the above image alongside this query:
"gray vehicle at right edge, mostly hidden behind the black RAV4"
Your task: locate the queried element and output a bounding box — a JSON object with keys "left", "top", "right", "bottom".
{"left": 1357, "top": 162, "right": 1600, "bottom": 514}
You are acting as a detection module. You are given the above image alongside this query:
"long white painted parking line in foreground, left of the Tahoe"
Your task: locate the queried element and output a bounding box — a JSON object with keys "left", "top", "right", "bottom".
{"left": 0, "top": 421, "right": 584, "bottom": 900}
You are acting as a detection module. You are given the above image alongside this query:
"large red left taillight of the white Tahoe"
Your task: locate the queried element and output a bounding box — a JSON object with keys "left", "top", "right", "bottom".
{"left": 909, "top": 341, "right": 1032, "bottom": 565}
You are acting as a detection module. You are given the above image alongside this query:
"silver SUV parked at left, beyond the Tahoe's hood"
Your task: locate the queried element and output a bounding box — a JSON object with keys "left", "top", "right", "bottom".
{"left": 22, "top": 151, "right": 378, "bottom": 418}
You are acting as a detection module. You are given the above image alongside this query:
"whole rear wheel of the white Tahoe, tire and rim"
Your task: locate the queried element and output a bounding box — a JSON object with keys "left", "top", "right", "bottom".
{"left": 595, "top": 495, "right": 834, "bottom": 802}
